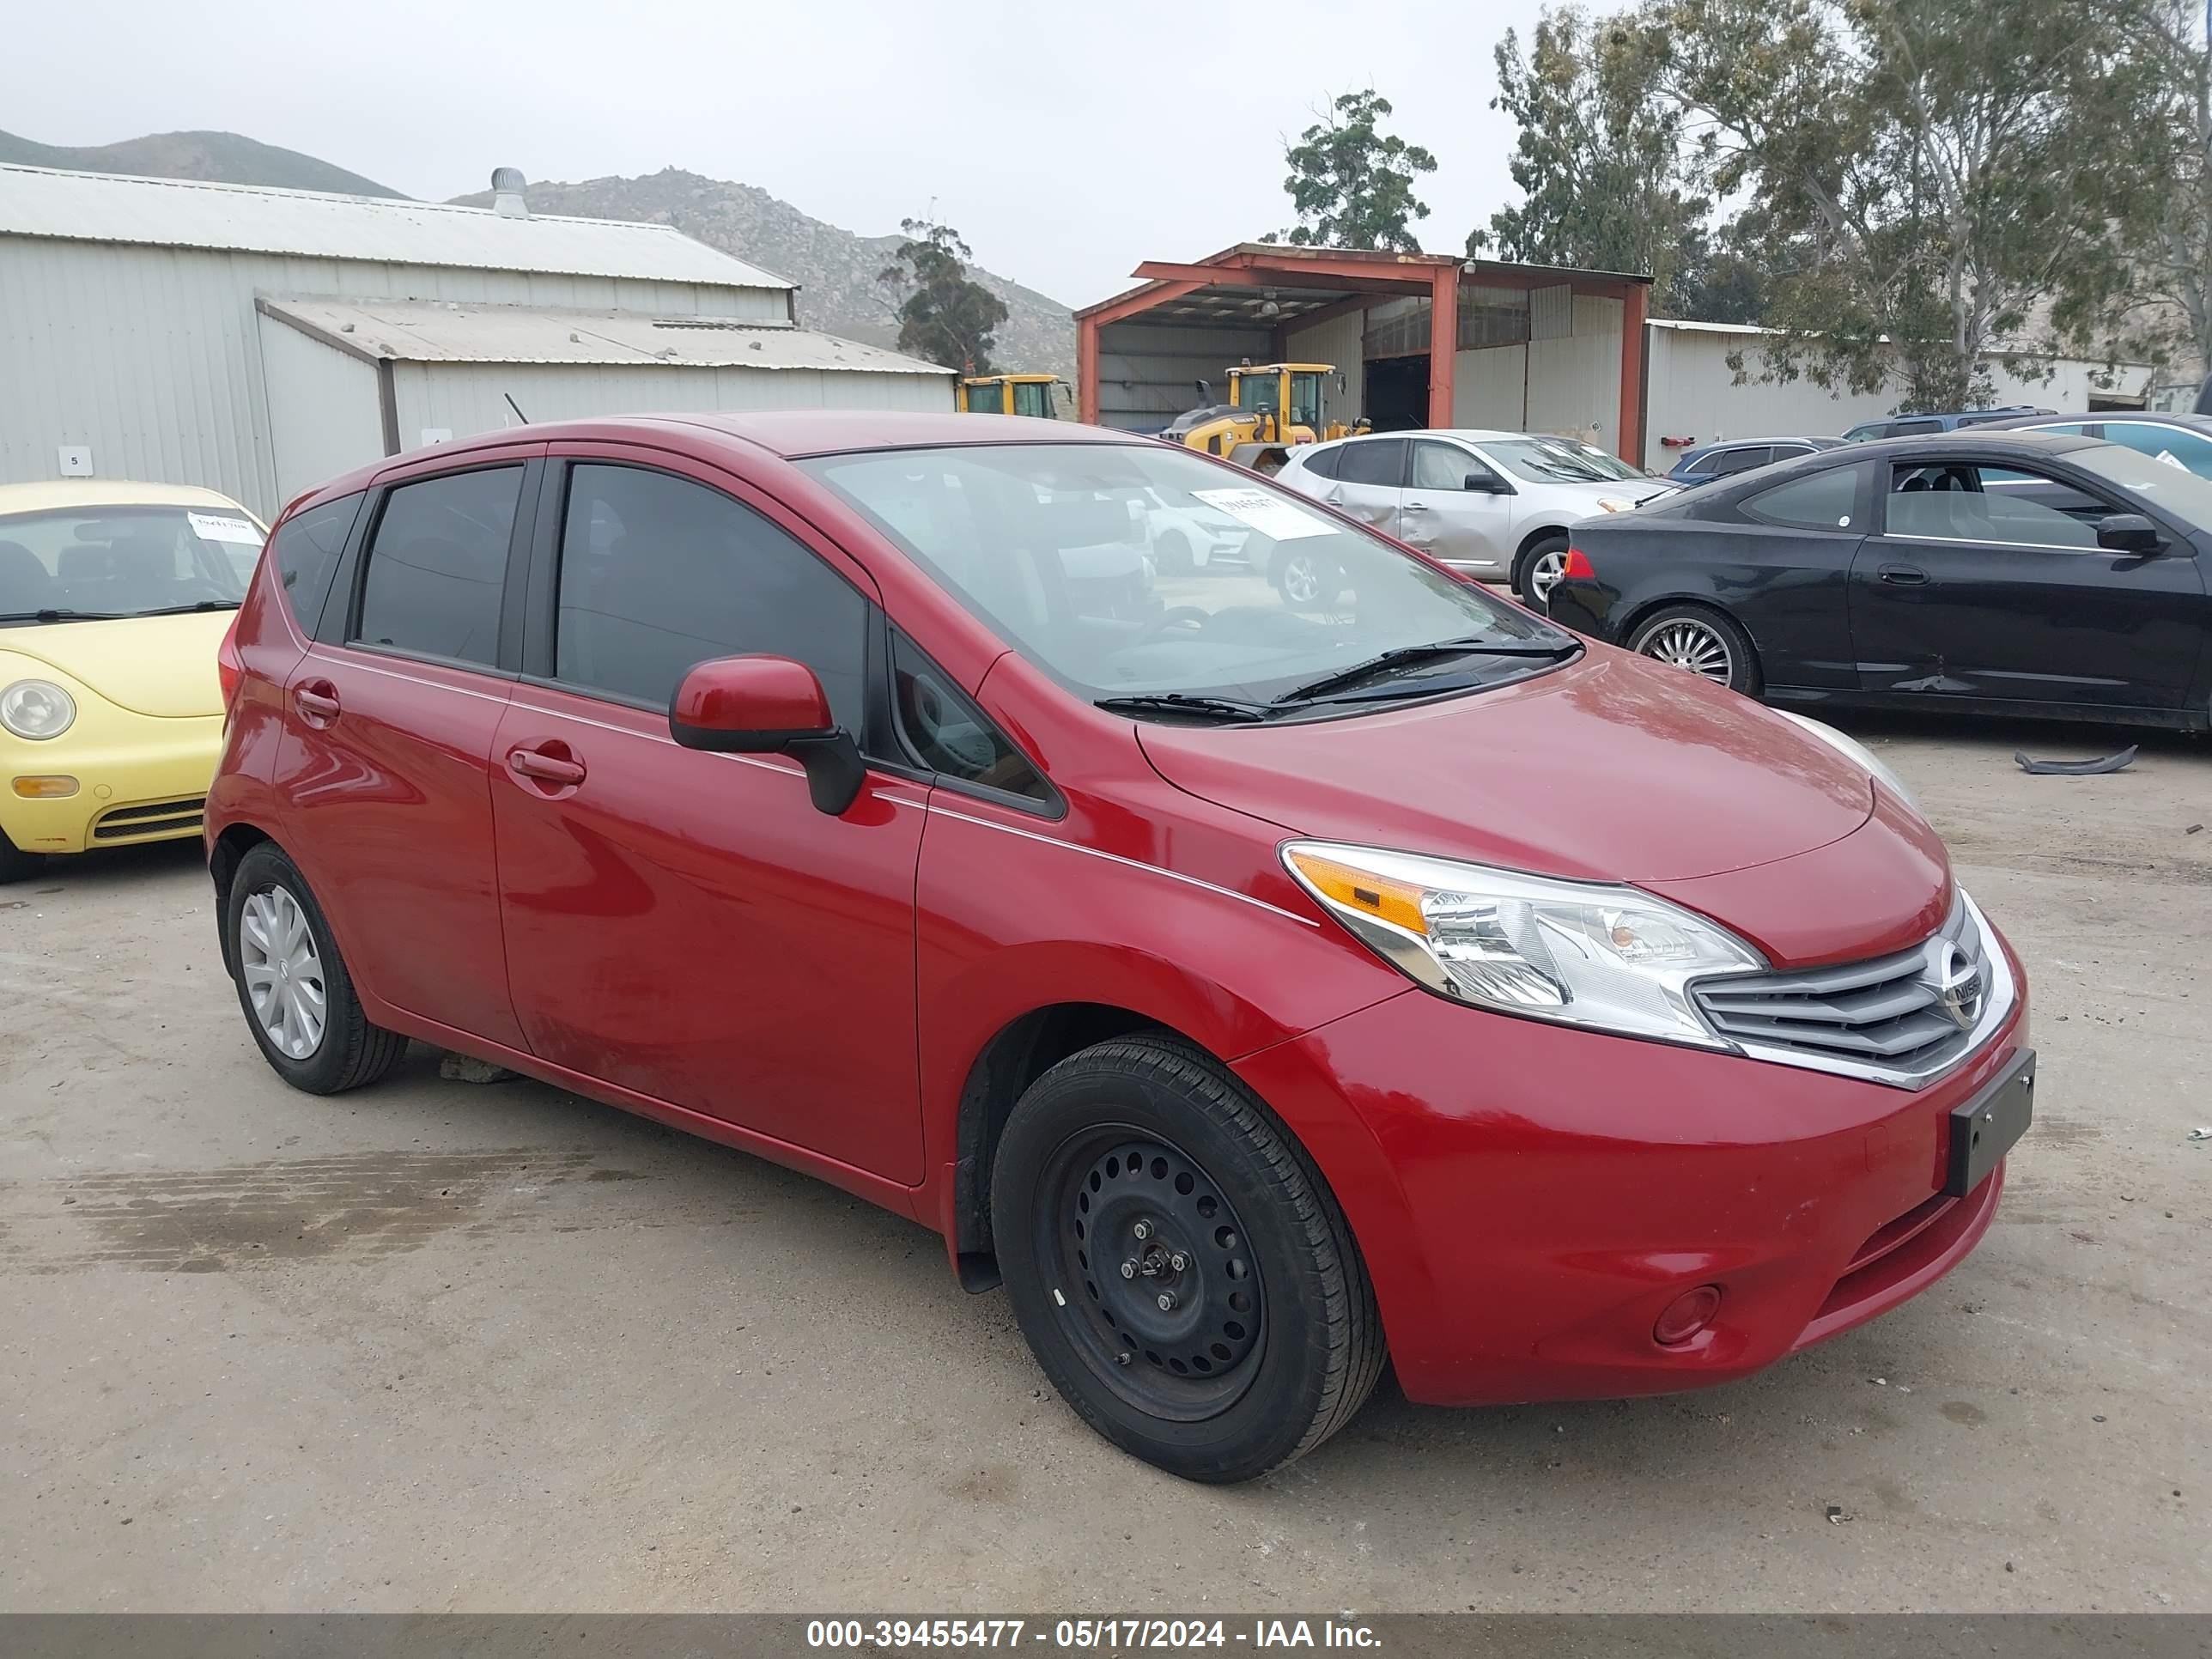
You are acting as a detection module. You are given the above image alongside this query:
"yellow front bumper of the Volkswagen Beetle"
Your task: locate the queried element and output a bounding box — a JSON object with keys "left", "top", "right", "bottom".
{"left": 0, "top": 710, "right": 223, "bottom": 852}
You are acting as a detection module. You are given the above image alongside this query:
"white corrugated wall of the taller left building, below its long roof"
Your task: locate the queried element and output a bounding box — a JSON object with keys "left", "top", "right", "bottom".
{"left": 0, "top": 234, "right": 792, "bottom": 514}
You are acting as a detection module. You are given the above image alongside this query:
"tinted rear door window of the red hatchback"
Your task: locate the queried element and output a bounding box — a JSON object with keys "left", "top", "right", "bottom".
{"left": 354, "top": 467, "right": 522, "bottom": 668}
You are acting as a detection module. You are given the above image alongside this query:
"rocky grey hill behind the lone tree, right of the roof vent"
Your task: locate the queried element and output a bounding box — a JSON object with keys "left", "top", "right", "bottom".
{"left": 456, "top": 168, "right": 1075, "bottom": 378}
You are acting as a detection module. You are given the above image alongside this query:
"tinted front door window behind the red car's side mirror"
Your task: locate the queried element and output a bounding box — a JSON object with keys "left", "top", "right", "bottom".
{"left": 553, "top": 465, "right": 867, "bottom": 732}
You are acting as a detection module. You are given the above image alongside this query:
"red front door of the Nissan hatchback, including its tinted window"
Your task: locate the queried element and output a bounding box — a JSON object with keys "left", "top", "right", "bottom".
{"left": 493, "top": 447, "right": 927, "bottom": 1183}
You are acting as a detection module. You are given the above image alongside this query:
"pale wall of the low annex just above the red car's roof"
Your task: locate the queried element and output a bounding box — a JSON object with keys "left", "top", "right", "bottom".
{"left": 389, "top": 358, "right": 953, "bottom": 448}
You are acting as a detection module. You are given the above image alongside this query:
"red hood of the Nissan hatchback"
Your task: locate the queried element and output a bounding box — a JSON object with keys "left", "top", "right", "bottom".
{"left": 1139, "top": 646, "right": 1874, "bottom": 883}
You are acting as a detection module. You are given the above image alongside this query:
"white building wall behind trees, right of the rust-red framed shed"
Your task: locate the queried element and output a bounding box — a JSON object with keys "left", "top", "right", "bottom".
{"left": 1644, "top": 327, "right": 2150, "bottom": 471}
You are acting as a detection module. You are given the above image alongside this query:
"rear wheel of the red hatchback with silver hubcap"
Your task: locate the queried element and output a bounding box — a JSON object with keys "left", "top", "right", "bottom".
{"left": 223, "top": 841, "right": 407, "bottom": 1095}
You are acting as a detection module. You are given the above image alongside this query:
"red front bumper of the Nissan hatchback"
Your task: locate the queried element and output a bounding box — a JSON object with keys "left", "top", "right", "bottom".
{"left": 1237, "top": 928, "right": 2028, "bottom": 1405}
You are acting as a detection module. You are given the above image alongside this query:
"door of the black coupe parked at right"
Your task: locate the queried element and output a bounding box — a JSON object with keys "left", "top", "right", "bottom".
{"left": 1851, "top": 452, "right": 2203, "bottom": 710}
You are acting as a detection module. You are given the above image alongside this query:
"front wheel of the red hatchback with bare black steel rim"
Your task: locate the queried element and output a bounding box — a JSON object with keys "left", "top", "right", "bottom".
{"left": 991, "top": 1037, "right": 1385, "bottom": 1482}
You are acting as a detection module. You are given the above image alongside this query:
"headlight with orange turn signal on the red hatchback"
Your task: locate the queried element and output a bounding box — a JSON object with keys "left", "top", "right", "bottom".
{"left": 1283, "top": 841, "right": 1765, "bottom": 1048}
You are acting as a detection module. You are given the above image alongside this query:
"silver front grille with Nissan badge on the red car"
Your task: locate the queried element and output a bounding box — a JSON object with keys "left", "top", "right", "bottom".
{"left": 1692, "top": 894, "right": 2013, "bottom": 1088}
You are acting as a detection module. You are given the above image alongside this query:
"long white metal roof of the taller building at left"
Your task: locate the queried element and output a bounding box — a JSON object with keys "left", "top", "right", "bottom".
{"left": 0, "top": 166, "right": 794, "bottom": 289}
